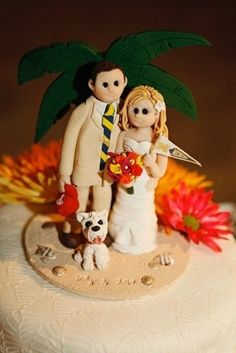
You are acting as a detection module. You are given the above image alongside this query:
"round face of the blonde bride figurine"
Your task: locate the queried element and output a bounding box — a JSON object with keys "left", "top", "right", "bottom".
{"left": 128, "top": 99, "right": 159, "bottom": 127}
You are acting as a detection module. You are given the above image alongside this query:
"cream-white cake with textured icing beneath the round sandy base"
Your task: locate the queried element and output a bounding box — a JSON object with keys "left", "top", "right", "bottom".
{"left": 0, "top": 206, "right": 236, "bottom": 353}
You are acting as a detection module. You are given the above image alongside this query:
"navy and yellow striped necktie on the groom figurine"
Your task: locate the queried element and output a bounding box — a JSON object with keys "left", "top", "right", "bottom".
{"left": 100, "top": 104, "right": 115, "bottom": 170}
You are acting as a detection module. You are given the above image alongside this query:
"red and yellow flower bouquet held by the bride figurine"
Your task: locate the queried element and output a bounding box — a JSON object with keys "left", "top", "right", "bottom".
{"left": 106, "top": 152, "right": 143, "bottom": 192}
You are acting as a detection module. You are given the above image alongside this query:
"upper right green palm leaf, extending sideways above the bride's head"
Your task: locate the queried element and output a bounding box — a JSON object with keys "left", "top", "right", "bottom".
{"left": 105, "top": 31, "right": 211, "bottom": 65}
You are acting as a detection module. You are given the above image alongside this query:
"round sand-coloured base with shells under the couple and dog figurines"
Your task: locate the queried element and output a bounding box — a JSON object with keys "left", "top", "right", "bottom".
{"left": 25, "top": 215, "right": 189, "bottom": 300}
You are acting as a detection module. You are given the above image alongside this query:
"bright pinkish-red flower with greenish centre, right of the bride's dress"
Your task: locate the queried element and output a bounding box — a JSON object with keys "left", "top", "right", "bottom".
{"left": 161, "top": 183, "right": 231, "bottom": 252}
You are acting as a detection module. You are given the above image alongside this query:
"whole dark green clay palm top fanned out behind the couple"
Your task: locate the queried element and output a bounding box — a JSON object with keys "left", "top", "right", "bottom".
{"left": 18, "top": 31, "right": 210, "bottom": 142}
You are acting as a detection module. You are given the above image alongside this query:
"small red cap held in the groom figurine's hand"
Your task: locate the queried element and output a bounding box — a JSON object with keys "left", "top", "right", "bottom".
{"left": 56, "top": 184, "right": 79, "bottom": 217}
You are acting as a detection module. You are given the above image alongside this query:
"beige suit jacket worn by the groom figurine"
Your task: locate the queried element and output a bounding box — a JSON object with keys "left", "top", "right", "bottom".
{"left": 59, "top": 96, "right": 120, "bottom": 186}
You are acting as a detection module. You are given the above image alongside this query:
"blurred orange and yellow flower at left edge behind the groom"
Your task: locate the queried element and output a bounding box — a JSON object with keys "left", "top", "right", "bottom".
{"left": 0, "top": 141, "right": 60, "bottom": 203}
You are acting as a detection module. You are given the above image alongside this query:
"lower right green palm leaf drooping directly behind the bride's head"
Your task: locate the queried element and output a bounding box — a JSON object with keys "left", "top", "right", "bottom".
{"left": 123, "top": 64, "right": 197, "bottom": 120}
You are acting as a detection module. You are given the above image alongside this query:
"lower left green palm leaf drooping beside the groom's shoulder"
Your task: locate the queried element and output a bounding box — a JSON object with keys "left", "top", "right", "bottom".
{"left": 35, "top": 73, "right": 78, "bottom": 142}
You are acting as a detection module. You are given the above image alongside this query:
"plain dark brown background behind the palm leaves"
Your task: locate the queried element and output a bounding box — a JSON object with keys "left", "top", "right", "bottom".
{"left": 0, "top": 0, "right": 236, "bottom": 201}
